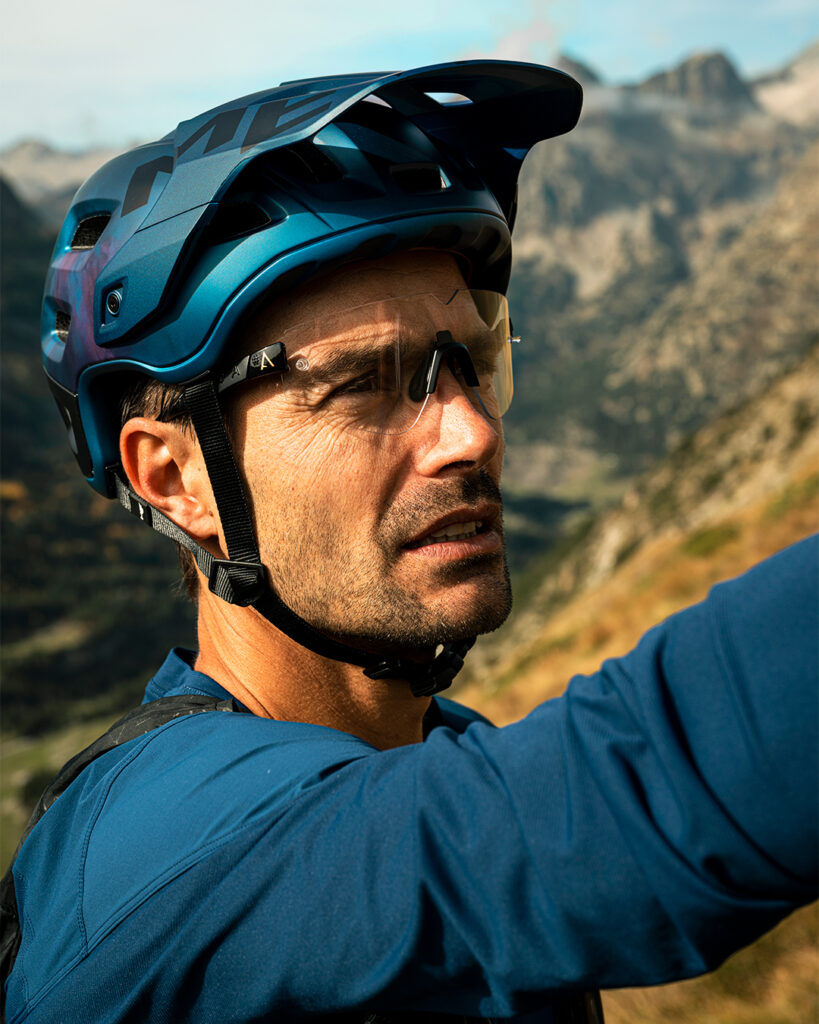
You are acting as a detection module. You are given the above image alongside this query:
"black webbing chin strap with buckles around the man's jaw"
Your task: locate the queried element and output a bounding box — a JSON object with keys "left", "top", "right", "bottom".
{"left": 112, "top": 379, "right": 476, "bottom": 696}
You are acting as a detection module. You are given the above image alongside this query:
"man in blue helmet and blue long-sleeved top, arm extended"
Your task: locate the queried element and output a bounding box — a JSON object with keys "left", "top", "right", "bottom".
{"left": 7, "top": 62, "right": 816, "bottom": 1022}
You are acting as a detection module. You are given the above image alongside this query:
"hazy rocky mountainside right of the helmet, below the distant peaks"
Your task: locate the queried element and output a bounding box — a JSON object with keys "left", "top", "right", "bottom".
{"left": 507, "top": 62, "right": 819, "bottom": 512}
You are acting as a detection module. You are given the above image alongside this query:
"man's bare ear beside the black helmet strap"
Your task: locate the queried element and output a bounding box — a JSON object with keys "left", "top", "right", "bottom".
{"left": 120, "top": 416, "right": 223, "bottom": 557}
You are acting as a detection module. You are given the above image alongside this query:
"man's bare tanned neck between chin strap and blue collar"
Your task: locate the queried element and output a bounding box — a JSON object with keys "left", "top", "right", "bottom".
{"left": 196, "top": 592, "right": 430, "bottom": 750}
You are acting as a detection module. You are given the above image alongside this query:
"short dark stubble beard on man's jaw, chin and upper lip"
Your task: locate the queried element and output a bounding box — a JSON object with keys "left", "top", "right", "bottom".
{"left": 265, "top": 470, "right": 512, "bottom": 651}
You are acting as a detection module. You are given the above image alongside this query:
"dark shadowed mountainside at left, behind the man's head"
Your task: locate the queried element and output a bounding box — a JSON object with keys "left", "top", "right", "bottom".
{"left": 0, "top": 178, "right": 193, "bottom": 733}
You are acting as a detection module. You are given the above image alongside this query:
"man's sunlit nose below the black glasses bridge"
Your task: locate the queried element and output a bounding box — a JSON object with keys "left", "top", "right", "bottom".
{"left": 413, "top": 366, "right": 504, "bottom": 476}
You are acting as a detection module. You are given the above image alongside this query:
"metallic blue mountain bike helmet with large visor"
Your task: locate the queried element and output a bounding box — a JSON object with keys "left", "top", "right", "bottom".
{"left": 42, "top": 60, "right": 581, "bottom": 691}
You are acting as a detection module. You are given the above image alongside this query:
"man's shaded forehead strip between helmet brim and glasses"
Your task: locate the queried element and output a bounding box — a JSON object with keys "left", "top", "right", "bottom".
{"left": 238, "top": 252, "right": 466, "bottom": 353}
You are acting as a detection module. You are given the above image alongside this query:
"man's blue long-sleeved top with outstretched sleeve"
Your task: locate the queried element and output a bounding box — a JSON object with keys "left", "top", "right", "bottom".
{"left": 7, "top": 538, "right": 819, "bottom": 1024}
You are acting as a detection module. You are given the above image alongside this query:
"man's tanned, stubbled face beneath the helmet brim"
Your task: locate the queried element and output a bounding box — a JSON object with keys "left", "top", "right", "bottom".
{"left": 232, "top": 253, "right": 511, "bottom": 650}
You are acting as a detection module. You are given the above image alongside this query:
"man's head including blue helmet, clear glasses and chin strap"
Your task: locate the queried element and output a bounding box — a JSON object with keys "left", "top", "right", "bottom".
{"left": 43, "top": 61, "right": 580, "bottom": 692}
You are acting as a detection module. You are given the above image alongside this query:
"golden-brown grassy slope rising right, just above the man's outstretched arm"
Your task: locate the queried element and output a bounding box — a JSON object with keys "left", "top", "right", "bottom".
{"left": 459, "top": 346, "right": 819, "bottom": 722}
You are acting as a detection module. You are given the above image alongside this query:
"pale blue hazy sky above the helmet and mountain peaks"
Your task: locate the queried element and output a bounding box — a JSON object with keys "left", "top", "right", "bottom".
{"left": 0, "top": 0, "right": 819, "bottom": 151}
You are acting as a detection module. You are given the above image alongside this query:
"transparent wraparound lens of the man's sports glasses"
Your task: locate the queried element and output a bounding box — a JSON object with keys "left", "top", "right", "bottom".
{"left": 268, "top": 290, "right": 512, "bottom": 434}
